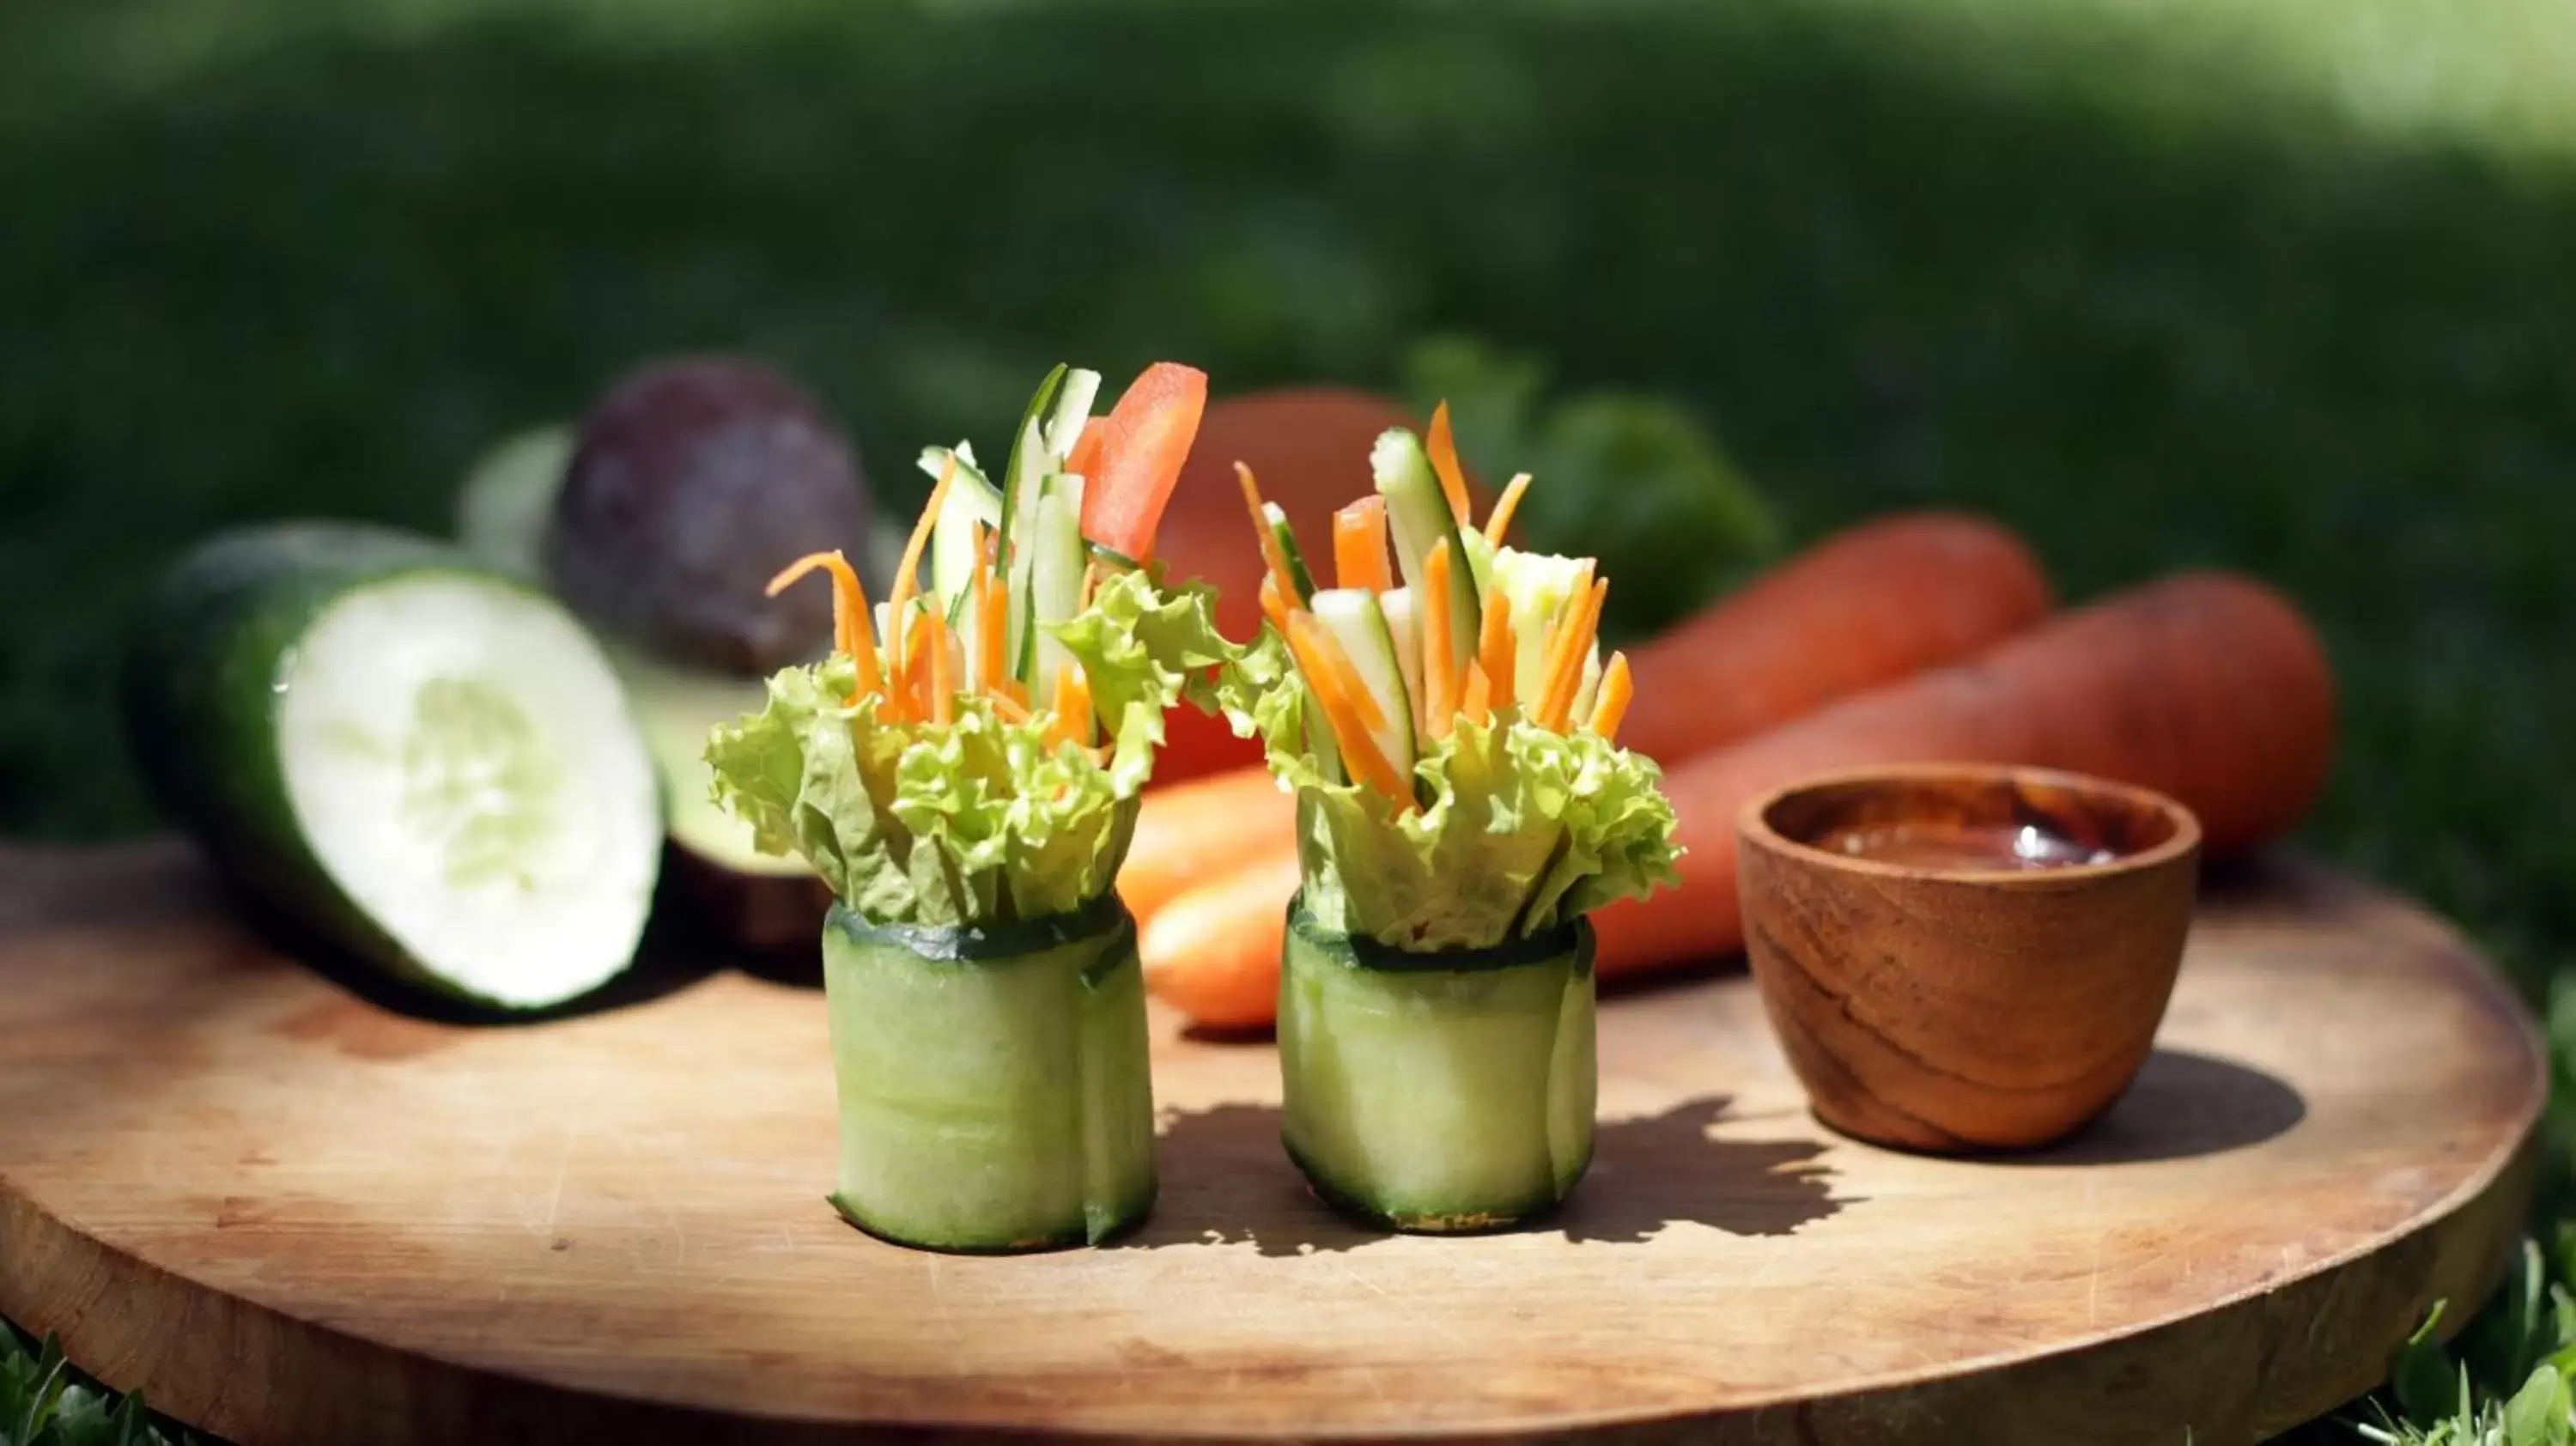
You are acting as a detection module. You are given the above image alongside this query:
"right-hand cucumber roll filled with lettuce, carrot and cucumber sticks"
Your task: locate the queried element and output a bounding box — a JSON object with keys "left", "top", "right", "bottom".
{"left": 1226, "top": 407, "right": 1677, "bottom": 1230}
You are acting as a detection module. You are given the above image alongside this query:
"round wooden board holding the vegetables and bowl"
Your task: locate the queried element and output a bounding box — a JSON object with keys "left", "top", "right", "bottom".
{"left": 0, "top": 846, "right": 2545, "bottom": 1446}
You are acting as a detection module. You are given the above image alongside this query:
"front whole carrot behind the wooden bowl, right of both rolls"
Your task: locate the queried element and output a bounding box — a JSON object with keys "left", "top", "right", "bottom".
{"left": 1595, "top": 572, "right": 2334, "bottom": 977}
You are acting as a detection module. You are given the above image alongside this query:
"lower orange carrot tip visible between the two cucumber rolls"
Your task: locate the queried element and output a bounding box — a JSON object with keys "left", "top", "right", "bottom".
{"left": 1149, "top": 854, "right": 1298, "bottom": 1029}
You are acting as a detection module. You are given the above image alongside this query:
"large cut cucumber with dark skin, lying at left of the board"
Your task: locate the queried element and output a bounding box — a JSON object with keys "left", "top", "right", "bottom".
{"left": 124, "top": 523, "right": 662, "bottom": 1008}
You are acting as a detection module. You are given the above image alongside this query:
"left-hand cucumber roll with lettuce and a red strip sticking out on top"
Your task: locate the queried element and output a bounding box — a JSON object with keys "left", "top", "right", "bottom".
{"left": 708, "top": 363, "right": 1236, "bottom": 1250}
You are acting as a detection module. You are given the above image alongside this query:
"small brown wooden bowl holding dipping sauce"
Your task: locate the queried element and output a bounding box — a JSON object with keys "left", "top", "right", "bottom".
{"left": 1736, "top": 763, "right": 2200, "bottom": 1155}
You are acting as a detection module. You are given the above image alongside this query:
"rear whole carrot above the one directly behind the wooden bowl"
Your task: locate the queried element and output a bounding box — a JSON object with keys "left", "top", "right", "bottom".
{"left": 1620, "top": 513, "right": 2048, "bottom": 766}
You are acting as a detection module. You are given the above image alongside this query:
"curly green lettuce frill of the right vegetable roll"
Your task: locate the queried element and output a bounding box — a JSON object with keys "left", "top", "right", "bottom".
{"left": 1221, "top": 634, "right": 1682, "bottom": 954}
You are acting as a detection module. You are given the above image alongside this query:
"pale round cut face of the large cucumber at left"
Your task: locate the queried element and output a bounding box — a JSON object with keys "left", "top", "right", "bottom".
{"left": 276, "top": 572, "right": 662, "bottom": 1008}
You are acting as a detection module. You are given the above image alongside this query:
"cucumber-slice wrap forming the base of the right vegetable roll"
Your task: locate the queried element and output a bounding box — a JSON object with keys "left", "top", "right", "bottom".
{"left": 1278, "top": 895, "right": 1597, "bottom": 1235}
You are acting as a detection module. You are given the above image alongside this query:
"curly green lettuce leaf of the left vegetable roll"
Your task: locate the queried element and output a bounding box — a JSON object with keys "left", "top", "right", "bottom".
{"left": 706, "top": 572, "right": 1239, "bottom": 926}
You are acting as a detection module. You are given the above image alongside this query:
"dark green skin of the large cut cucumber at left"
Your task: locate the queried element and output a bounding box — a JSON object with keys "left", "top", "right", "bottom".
{"left": 121, "top": 523, "right": 554, "bottom": 1008}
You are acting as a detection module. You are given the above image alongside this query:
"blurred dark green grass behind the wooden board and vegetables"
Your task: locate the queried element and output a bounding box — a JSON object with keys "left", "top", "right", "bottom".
{"left": 0, "top": 0, "right": 2576, "bottom": 1432}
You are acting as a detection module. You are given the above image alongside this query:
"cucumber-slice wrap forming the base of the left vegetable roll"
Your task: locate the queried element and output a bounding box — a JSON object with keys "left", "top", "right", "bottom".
{"left": 822, "top": 895, "right": 1154, "bottom": 1253}
